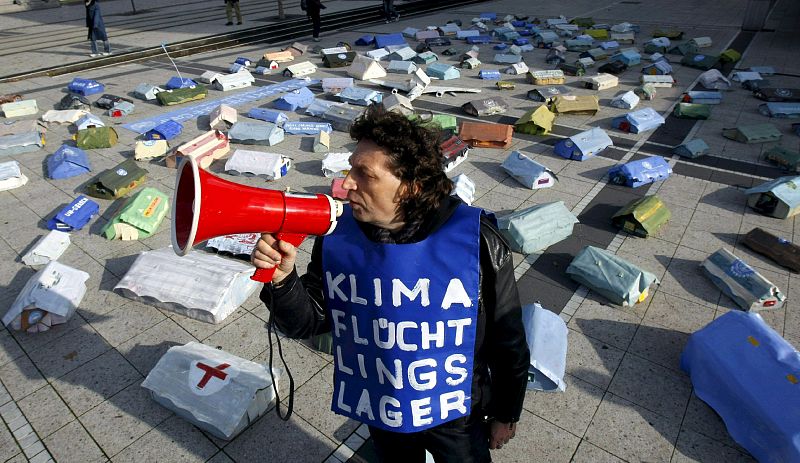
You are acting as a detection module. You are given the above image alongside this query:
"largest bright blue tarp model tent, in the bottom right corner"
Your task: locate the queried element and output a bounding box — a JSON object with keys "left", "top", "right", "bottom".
{"left": 681, "top": 310, "right": 800, "bottom": 463}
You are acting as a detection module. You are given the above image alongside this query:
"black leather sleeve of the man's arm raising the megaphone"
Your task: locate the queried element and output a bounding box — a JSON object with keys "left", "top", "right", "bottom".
{"left": 260, "top": 237, "right": 331, "bottom": 338}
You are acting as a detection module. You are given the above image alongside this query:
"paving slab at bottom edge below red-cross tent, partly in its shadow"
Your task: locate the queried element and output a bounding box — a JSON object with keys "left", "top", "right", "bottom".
{"left": 112, "top": 416, "right": 217, "bottom": 462}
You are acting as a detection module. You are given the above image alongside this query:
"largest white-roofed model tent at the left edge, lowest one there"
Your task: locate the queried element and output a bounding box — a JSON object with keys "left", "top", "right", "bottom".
{"left": 3, "top": 261, "right": 89, "bottom": 333}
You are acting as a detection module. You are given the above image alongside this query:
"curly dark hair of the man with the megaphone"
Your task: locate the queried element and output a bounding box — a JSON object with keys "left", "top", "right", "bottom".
{"left": 350, "top": 105, "right": 453, "bottom": 228}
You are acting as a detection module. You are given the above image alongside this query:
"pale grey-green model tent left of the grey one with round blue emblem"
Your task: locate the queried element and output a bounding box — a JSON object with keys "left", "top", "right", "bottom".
{"left": 566, "top": 246, "right": 658, "bottom": 306}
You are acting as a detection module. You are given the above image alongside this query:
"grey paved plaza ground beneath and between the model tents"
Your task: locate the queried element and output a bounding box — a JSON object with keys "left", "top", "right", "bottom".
{"left": 0, "top": 0, "right": 800, "bottom": 463}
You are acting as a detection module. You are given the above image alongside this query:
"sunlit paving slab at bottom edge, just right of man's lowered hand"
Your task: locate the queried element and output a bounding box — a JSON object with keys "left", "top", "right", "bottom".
{"left": 492, "top": 411, "right": 580, "bottom": 462}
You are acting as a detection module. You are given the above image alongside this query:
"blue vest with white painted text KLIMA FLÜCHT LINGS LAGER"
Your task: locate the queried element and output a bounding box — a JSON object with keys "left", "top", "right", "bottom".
{"left": 322, "top": 204, "right": 481, "bottom": 433}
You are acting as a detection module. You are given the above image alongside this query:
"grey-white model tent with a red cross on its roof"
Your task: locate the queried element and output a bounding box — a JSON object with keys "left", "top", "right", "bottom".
{"left": 142, "top": 342, "right": 279, "bottom": 440}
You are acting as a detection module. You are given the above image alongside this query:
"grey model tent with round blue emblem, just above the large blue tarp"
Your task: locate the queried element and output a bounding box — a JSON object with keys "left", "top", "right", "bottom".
{"left": 701, "top": 248, "right": 786, "bottom": 312}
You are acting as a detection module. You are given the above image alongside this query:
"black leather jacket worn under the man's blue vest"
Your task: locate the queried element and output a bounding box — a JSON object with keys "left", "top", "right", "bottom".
{"left": 261, "top": 198, "right": 530, "bottom": 423}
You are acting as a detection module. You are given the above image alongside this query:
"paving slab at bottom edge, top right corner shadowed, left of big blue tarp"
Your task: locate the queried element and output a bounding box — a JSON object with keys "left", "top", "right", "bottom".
{"left": 585, "top": 393, "right": 680, "bottom": 462}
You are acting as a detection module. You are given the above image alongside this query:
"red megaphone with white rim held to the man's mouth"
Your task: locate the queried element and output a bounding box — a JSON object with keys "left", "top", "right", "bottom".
{"left": 172, "top": 156, "right": 342, "bottom": 283}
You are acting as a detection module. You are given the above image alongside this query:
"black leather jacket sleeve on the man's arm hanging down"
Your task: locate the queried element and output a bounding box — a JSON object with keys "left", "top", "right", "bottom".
{"left": 481, "top": 220, "right": 530, "bottom": 423}
